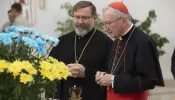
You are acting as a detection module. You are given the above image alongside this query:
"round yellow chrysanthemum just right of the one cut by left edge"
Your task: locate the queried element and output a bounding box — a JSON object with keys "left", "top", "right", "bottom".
{"left": 8, "top": 61, "right": 23, "bottom": 76}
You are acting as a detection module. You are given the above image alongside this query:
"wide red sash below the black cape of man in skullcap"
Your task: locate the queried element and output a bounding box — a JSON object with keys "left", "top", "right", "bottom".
{"left": 107, "top": 87, "right": 148, "bottom": 100}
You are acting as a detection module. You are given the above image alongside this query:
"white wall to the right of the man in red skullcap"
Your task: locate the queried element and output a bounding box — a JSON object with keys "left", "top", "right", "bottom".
{"left": 124, "top": 0, "right": 175, "bottom": 79}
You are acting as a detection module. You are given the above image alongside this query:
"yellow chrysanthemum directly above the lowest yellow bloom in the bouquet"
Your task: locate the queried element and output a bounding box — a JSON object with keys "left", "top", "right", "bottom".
{"left": 22, "top": 61, "right": 37, "bottom": 75}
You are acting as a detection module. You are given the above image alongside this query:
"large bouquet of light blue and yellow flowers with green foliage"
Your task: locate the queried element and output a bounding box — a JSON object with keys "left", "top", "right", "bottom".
{"left": 0, "top": 26, "right": 70, "bottom": 100}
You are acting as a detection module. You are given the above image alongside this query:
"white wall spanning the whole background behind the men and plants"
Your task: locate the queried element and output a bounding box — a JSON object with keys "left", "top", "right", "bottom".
{"left": 0, "top": 0, "right": 175, "bottom": 79}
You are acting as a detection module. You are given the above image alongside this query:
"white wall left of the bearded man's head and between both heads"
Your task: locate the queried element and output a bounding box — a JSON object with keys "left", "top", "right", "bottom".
{"left": 34, "top": 0, "right": 117, "bottom": 36}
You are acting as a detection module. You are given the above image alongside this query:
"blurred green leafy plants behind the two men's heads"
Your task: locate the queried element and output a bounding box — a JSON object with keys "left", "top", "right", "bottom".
{"left": 56, "top": 2, "right": 169, "bottom": 56}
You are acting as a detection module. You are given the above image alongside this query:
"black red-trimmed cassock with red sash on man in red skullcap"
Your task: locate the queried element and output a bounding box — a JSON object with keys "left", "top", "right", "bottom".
{"left": 107, "top": 26, "right": 164, "bottom": 100}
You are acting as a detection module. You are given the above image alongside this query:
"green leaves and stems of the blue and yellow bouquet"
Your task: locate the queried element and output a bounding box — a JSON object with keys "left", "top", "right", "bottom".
{"left": 0, "top": 42, "right": 56, "bottom": 100}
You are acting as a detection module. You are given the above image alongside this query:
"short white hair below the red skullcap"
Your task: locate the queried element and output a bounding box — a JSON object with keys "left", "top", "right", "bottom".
{"left": 102, "top": 6, "right": 132, "bottom": 24}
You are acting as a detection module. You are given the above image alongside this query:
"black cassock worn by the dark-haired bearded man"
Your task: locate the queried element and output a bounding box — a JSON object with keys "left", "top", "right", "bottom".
{"left": 50, "top": 28, "right": 112, "bottom": 100}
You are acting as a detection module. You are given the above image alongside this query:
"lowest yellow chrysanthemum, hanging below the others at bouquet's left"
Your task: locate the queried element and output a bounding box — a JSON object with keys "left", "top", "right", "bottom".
{"left": 20, "top": 73, "right": 34, "bottom": 84}
